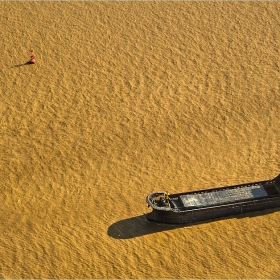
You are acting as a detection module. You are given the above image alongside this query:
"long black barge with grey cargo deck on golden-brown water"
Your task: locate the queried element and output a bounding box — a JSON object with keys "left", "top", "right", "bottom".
{"left": 146, "top": 174, "right": 280, "bottom": 224}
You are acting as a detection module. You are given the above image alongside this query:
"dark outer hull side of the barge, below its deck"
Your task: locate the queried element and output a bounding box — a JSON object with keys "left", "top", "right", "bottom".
{"left": 146, "top": 175, "right": 280, "bottom": 224}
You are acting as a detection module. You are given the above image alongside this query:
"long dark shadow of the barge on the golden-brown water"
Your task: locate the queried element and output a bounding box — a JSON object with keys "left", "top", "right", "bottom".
{"left": 107, "top": 208, "right": 280, "bottom": 239}
